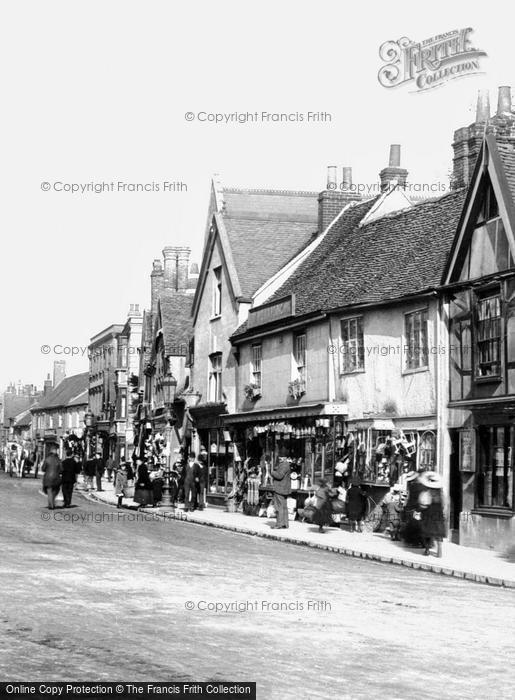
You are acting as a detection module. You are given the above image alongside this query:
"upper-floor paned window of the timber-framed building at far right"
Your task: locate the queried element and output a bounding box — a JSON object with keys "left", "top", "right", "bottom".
{"left": 476, "top": 291, "right": 501, "bottom": 378}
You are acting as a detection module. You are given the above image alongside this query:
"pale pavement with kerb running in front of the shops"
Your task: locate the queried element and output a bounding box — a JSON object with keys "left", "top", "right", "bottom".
{"left": 82, "top": 482, "right": 515, "bottom": 588}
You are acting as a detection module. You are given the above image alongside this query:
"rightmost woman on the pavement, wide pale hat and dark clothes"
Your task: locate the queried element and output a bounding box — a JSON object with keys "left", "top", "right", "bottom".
{"left": 417, "top": 471, "right": 447, "bottom": 557}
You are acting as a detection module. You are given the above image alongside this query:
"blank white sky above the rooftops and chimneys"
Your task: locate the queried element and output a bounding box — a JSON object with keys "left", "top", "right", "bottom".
{"left": 0, "top": 0, "right": 515, "bottom": 390}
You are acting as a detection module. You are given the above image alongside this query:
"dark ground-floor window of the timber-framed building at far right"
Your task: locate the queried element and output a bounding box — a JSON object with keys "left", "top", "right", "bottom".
{"left": 476, "top": 425, "right": 513, "bottom": 508}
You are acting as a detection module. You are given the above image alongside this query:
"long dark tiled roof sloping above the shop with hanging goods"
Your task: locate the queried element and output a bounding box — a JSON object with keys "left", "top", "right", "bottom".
{"left": 233, "top": 190, "right": 466, "bottom": 337}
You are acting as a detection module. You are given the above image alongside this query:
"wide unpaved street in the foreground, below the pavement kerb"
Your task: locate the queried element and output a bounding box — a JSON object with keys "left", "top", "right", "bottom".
{"left": 0, "top": 473, "right": 515, "bottom": 700}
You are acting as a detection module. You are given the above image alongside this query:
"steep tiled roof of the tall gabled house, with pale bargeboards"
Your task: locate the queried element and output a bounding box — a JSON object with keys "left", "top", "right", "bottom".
{"left": 192, "top": 181, "right": 318, "bottom": 317}
